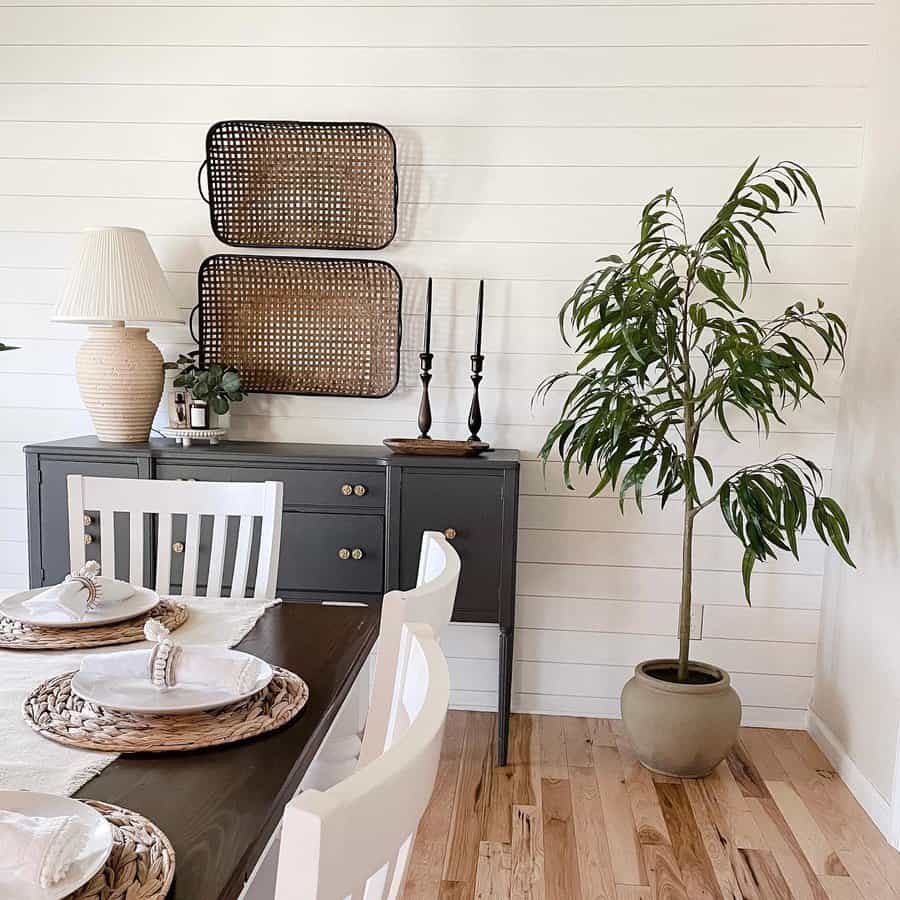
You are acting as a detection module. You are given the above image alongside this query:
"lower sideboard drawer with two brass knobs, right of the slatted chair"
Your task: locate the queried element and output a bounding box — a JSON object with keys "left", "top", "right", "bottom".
{"left": 278, "top": 511, "right": 384, "bottom": 599}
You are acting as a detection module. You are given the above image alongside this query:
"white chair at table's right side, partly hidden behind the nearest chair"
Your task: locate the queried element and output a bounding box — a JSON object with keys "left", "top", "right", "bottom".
{"left": 359, "top": 531, "right": 460, "bottom": 766}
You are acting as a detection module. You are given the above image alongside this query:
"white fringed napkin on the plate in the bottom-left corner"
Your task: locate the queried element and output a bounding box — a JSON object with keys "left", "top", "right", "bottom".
{"left": 0, "top": 809, "right": 90, "bottom": 888}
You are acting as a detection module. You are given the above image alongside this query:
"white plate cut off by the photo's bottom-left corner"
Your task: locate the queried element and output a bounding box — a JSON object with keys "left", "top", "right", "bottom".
{"left": 0, "top": 791, "right": 113, "bottom": 900}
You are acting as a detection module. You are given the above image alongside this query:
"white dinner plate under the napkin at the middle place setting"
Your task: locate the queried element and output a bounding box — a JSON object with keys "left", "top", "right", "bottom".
{"left": 72, "top": 647, "right": 273, "bottom": 716}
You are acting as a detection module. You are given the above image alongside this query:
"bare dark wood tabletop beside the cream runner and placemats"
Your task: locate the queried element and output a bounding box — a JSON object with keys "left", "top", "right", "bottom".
{"left": 75, "top": 603, "right": 378, "bottom": 900}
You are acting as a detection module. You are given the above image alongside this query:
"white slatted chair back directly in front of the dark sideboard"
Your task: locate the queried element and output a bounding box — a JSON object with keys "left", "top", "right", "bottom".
{"left": 67, "top": 475, "right": 283, "bottom": 599}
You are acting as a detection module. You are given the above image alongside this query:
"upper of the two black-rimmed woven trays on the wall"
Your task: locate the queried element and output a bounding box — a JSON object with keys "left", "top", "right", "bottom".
{"left": 206, "top": 121, "right": 397, "bottom": 250}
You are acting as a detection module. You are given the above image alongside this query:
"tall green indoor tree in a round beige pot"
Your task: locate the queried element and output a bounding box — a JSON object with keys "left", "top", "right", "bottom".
{"left": 536, "top": 161, "right": 852, "bottom": 777}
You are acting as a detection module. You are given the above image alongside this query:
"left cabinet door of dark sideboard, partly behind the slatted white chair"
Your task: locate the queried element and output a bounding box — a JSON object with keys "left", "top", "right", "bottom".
{"left": 31, "top": 457, "right": 141, "bottom": 587}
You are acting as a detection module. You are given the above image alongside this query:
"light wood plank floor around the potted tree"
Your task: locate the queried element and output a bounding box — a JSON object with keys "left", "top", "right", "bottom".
{"left": 404, "top": 712, "right": 900, "bottom": 900}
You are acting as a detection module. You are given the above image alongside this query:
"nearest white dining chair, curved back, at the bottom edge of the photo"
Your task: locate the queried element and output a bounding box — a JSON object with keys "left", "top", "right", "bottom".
{"left": 275, "top": 623, "right": 450, "bottom": 900}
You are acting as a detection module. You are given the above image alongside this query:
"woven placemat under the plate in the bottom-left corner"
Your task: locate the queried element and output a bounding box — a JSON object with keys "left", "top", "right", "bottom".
{"left": 66, "top": 800, "right": 175, "bottom": 900}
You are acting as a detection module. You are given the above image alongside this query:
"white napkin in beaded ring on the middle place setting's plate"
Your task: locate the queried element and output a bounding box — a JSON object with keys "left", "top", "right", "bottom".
{"left": 81, "top": 619, "right": 262, "bottom": 694}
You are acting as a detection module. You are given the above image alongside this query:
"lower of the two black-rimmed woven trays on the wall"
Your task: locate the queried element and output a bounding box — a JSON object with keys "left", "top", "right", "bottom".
{"left": 199, "top": 254, "right": 402, "bottom": 397}
